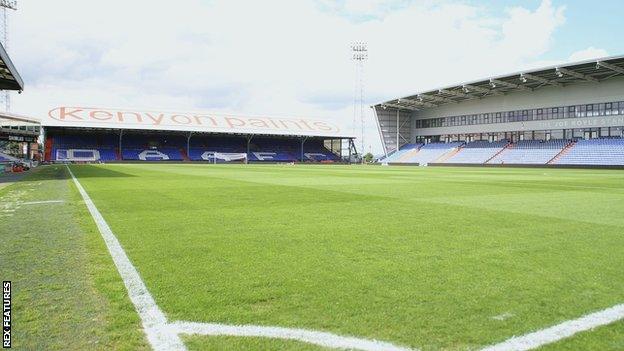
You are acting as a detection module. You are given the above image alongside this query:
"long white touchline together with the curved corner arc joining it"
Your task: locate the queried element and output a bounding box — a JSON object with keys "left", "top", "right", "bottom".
{"left": 67, "top": 166, "right": 416, "bottom": 351}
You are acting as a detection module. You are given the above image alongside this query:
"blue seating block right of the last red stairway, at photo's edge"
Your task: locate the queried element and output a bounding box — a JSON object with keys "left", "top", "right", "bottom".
{"left": 555, "top": 138, "right": 624, "bottom": 166}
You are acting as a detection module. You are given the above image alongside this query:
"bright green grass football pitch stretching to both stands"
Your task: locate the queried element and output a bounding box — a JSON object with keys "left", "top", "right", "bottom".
{"left": 0, "top": 164, "right": 624, "bottom": 350}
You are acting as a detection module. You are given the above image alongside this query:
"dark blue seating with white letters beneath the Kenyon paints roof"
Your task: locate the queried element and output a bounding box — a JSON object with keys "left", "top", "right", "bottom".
{"left": 46, "top": 131, "right": 340, "bottom": 162}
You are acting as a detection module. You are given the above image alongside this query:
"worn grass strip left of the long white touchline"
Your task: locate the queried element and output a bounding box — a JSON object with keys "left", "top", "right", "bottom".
{"left": 0, "top": 166, "right": 148, "bottom": 350}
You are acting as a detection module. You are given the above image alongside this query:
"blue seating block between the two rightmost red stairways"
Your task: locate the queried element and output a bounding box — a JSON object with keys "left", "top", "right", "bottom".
{"left": 488, "top": 140, "right": 569, "bottom": 164}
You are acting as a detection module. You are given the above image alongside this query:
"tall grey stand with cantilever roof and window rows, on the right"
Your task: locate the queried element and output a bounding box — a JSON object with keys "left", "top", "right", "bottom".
{"left": 373, "top": 56, "right": 624, "bottom": 167}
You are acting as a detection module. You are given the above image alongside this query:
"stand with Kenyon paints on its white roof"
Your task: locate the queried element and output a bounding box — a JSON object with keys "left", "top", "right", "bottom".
{"left": 44, "top": 107, "right": 356, "bottom": 163}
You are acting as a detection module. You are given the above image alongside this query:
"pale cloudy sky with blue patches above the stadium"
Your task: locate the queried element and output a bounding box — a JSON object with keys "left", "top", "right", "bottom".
{"left": 8, "top": 0, "right": 624, "bottom": 154}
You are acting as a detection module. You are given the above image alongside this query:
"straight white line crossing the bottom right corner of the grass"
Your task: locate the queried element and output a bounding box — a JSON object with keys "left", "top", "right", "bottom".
{"left": 481, "top": 304, "right": 624, "bottom": 351}
